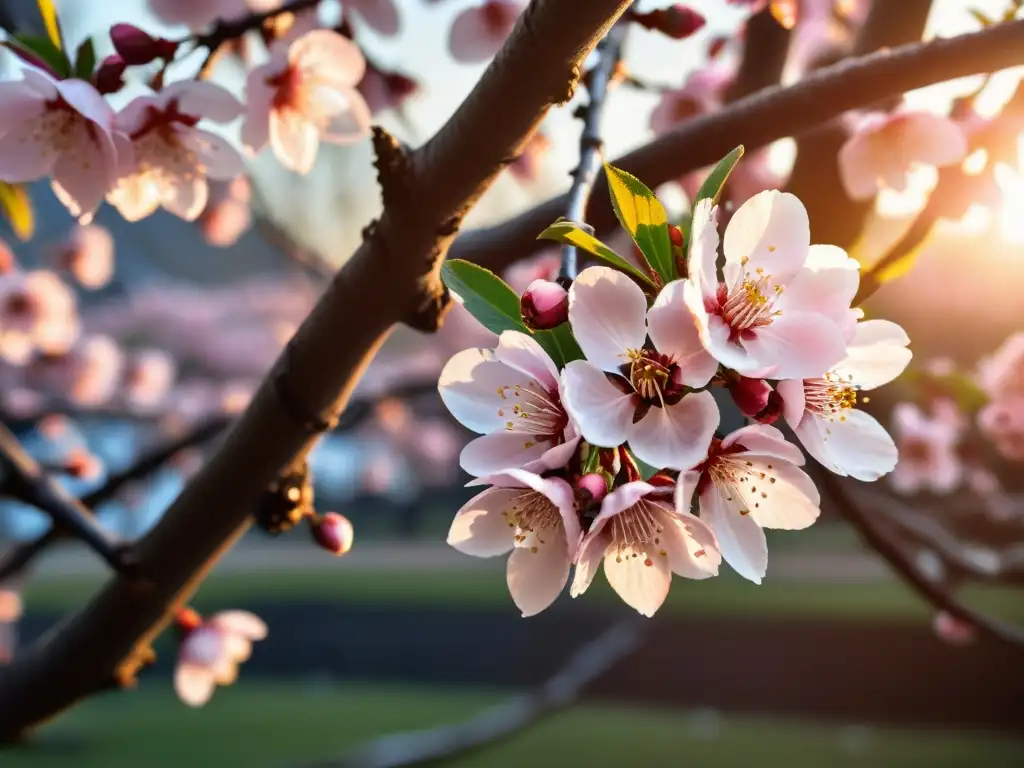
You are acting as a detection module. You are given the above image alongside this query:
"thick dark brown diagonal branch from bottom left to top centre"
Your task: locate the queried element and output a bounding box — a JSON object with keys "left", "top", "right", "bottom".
{"left": 0, "top": 0, "right": 630, "bottom": 740}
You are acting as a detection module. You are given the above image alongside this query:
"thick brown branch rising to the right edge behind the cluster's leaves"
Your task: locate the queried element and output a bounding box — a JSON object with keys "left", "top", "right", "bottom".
{"left": 452, "top": 19, "right": 1024, "bottom": 270}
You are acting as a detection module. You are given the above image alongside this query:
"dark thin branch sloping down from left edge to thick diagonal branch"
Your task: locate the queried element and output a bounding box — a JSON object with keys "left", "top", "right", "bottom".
{"left": 0, "top": 424, "right": 124, "bottom": 570}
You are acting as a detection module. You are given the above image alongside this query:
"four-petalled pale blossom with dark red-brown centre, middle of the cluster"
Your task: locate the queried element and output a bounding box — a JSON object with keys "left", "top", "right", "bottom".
{"left": 562, "top": 266, "right": 719, "bottom": 469}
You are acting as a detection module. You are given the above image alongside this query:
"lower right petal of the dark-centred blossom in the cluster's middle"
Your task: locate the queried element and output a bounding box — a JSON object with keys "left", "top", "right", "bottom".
{"left": 626, "top": 391, "right": 721, "bottom": 469}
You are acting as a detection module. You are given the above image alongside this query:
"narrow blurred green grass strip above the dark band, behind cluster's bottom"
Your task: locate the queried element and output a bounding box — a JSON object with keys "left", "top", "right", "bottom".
{"left": 26, "top": 561, "right": 1024, "bottom": 621}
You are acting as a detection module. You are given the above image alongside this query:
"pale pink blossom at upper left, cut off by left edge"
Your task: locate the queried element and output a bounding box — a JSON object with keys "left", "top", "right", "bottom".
{"left": 0, "top": 68, "right": 125, "bottom": 223}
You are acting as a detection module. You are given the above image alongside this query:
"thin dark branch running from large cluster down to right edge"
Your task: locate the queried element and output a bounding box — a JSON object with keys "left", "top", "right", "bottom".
{"left": 815, "top": 470, "right": 1024, "bottom": 650}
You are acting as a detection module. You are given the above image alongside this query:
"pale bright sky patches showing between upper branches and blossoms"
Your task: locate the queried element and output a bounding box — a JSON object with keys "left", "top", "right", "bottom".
{"left": 4, "top": 0, "right": 1017, "bottom": 260}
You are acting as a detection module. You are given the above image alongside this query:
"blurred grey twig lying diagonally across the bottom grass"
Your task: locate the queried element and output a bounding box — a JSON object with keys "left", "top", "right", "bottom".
{"left": 303, "top": 618, "right": 645, "bottom": 768}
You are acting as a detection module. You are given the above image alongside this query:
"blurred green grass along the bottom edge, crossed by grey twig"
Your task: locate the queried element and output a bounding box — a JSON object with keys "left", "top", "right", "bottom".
{"left": 6, "top": 680, "right": 1024, "bottom": 768}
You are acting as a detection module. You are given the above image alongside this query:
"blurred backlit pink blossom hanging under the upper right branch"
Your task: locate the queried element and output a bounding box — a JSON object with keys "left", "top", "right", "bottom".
{"left": 839, "top": 112, "right": 968, "bottom": 200}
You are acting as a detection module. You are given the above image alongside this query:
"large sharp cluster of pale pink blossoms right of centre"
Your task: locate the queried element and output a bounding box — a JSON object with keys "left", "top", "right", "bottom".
{"left": 438, "top": 167, "right": 910, "bottom": 615}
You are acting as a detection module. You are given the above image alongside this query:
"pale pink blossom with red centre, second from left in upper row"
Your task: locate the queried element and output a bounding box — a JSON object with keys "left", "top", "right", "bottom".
{"left": 108, "top": 81, "right": 243, "bottom": 221}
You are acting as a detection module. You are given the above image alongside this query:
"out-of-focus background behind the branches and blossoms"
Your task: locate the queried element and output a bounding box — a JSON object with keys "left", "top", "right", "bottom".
{"left": 0, "top": 0, "right": 1024, "bottom": 768}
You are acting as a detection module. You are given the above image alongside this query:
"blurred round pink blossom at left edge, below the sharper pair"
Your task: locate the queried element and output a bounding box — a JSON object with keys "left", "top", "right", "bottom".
{"left": 0, "top": 269, "right": 79, "bottom": 365}
